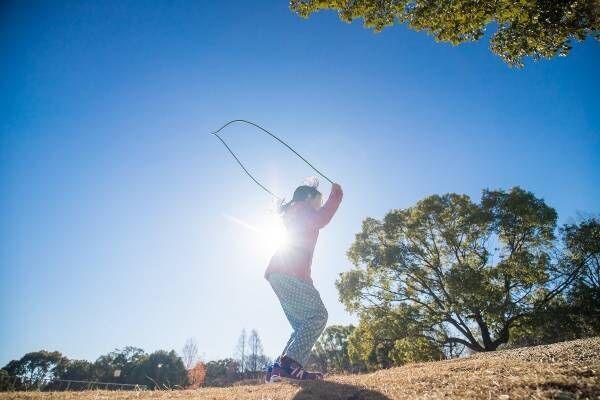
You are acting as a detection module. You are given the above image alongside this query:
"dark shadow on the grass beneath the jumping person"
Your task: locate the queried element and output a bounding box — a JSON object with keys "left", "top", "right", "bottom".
{"left": 294, "top": 381, "right": 390, "bottom": 400}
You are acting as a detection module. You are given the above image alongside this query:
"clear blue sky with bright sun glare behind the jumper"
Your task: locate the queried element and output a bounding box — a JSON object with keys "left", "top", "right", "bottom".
{"left": 0, "top": 0, "right": 600, "bottom": 365}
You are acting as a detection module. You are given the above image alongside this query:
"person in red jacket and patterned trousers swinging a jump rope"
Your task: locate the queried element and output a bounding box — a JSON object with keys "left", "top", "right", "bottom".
{"left": 265, "top": 183, "right": 343, "bottom": 383}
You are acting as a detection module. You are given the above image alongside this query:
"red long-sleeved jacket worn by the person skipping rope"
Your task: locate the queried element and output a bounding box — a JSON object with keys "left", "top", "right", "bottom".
{"left": 265, "top": 188, "right": 343, "bottom": 283}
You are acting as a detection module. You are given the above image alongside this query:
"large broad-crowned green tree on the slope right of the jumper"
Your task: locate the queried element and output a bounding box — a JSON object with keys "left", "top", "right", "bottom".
{"left": 336, "top": 187, "right": 582, "bottom": 354}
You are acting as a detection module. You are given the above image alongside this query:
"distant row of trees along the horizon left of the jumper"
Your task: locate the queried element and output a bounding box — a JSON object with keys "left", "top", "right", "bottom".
{"left": 0, "top": 330, "right": 271, "bottom": 391}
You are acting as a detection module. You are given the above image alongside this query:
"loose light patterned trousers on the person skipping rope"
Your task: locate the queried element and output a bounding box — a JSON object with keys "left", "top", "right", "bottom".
{"left": 269, "top": 272, "right": 327, "bottom": 366}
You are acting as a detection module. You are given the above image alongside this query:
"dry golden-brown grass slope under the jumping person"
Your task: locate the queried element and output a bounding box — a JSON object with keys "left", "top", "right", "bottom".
{"left": 0, "top": 337, "right": 600, "bottom": 400}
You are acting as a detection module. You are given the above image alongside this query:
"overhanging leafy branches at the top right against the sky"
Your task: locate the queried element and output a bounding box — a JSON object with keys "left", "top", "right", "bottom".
{"left": 290, "top": 0, "right": 600, "bottom": 67}
